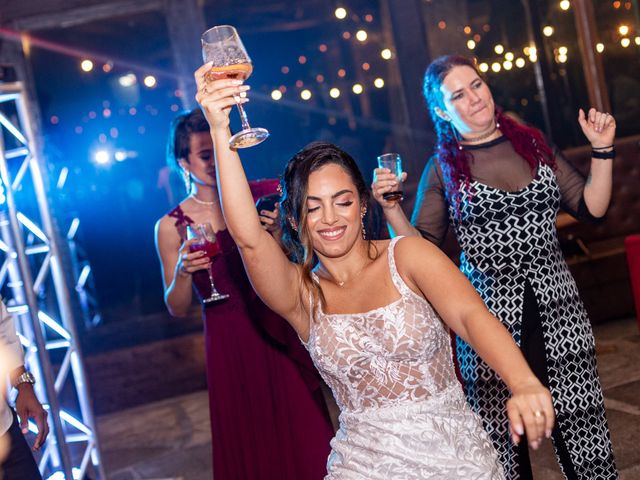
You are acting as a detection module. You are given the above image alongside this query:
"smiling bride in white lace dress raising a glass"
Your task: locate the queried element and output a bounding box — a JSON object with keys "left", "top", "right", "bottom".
{"left": 196, "top": 65, "right": 554, "bottom": 480}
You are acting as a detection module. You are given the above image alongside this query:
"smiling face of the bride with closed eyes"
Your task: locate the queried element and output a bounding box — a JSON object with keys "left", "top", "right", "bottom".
{"left": 306, "top": 163, "right": 362, "bottom": 258}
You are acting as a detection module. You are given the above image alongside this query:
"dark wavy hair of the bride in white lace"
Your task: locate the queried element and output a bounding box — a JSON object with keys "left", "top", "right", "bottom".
{"left": 280, "top": 142, "right": 377, "bottom": 316}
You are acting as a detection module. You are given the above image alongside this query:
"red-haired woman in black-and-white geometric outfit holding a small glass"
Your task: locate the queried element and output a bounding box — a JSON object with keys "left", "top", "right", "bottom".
{"left": 373, "top": 56, "right": 617, "bottom": 480}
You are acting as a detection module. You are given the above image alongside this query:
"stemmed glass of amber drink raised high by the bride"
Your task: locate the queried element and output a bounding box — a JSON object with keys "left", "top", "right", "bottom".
{"left": 202, "top": 25, "right": 269, "bottom": 148}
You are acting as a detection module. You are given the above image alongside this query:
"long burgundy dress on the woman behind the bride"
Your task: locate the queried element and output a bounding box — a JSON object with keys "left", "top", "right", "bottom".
{"left": 169, "top": 206, "right": 333, "bottom": 480}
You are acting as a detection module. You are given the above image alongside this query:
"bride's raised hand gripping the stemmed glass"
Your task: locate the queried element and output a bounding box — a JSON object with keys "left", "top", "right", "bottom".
{"left": 195, "top": 63, "right": 251, "bottom": 129}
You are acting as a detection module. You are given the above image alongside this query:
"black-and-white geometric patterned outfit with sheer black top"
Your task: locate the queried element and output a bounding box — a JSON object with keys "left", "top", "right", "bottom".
{"left": 414, "top": 136, "right": 618, "bottom": 480}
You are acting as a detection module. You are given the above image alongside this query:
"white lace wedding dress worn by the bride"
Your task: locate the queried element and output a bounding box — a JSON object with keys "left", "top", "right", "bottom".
{"left": 306, "top": 237, "right": 504, "bottom": 480}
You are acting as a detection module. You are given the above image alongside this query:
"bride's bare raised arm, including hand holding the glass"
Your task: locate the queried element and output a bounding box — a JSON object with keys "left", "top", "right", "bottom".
{"left": 195, "top": 64, "right": 309, "bottom": 336}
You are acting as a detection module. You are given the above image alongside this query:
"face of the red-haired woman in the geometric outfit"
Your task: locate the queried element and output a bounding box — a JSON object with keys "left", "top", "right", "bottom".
{"left": 436, "top": 65, "right": 495, "bottom": 137}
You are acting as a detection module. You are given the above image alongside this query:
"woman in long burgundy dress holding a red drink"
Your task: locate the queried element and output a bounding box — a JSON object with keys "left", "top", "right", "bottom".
{"left": 156, "top": 109, "right": 333, "bottom": 480}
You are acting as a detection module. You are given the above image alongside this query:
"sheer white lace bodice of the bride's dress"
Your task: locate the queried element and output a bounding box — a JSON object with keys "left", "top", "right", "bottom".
{"left": 307, "top": 237, "right": 462, "bottom": 411}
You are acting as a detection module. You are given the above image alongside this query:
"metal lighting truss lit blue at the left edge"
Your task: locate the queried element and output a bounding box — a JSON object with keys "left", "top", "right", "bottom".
{"left": 0, "top": 82, "right": 106, "bottom": 480}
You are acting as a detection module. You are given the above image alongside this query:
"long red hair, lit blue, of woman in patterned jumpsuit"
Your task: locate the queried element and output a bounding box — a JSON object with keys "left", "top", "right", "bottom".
{"left": 423, "top": 55, "right": 556, "bottom": 214}
